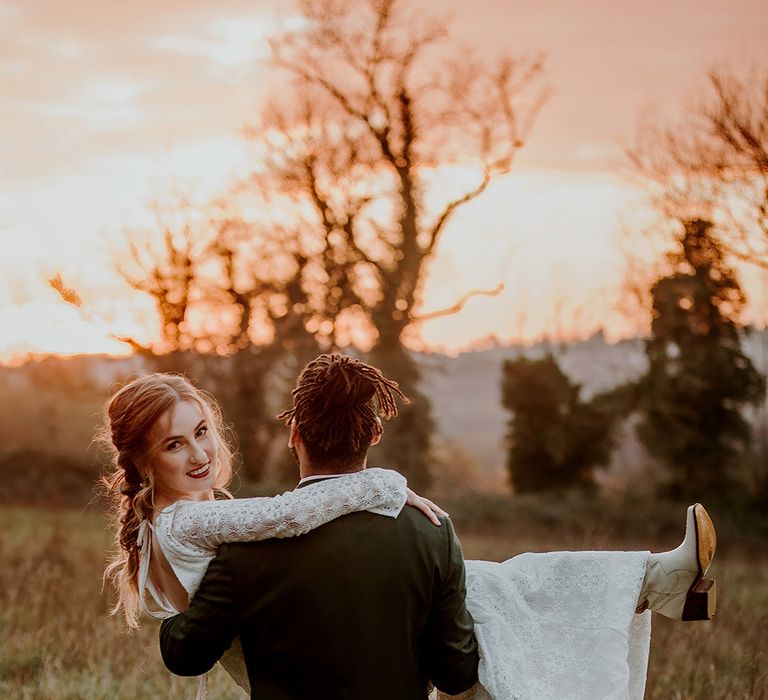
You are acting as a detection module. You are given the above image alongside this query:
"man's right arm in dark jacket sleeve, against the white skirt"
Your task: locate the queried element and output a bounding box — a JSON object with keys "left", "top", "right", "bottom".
{"left": 425, "top": 518, "right": 480, "bottom": 695}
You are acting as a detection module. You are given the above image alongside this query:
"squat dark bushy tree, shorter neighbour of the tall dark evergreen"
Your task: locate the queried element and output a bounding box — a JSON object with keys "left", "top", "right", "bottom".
{"left": 502, "top": 355, "right": 613, "bottom": 493}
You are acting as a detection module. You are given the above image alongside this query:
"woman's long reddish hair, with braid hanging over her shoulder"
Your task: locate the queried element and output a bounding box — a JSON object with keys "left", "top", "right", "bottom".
{"left": 97, "top": 372, "right": 232, "bottom": 628}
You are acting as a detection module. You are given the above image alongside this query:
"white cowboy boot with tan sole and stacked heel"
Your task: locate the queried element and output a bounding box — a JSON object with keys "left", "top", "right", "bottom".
{"left": 637, "top": 503, "right": 717, "bottom": 620}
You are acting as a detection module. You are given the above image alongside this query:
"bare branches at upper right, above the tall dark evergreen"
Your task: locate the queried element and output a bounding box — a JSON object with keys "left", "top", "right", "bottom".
{"left": 629, "top": 68, "right": 768, "bottom": 268}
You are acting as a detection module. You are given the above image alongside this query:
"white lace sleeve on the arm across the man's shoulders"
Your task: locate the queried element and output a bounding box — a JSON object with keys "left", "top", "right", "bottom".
{"left": 169, "top": 468, "right": 407, "bottom": 551}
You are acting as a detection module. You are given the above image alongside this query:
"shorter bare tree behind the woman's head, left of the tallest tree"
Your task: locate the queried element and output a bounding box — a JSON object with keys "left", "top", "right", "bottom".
{"left": 117, "top": 202, "right": 317, "bottom": 479}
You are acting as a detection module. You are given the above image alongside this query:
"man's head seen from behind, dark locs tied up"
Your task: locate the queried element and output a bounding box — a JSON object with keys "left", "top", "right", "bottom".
{"left": 278, "top": 354, "right": 408, "bottom": 473}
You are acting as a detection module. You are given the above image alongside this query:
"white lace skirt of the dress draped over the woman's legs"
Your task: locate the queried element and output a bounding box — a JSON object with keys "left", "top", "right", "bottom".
{"left": 466, "top": 552, "right": 651, "bottom": 700}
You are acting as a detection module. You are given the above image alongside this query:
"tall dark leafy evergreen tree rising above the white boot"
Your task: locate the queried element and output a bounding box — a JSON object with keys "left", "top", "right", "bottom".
{"left": 638, "top": 219, "right": 765, "bottom": 498}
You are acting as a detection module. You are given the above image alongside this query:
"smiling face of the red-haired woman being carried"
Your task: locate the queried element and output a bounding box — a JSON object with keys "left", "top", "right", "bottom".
{"left": 149, "top": 401, "right": 217, "bottom": 506}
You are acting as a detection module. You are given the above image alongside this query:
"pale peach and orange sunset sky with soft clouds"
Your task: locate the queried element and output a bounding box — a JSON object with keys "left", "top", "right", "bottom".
{"left": 0, "top": 0, "right": 768, "bottom": 359}
